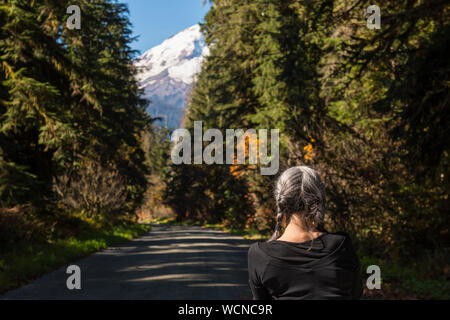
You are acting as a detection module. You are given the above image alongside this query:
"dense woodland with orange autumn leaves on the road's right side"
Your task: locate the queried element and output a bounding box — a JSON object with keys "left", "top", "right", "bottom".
{"left": 165, "top": 0, "right": 450, "bottom": 288}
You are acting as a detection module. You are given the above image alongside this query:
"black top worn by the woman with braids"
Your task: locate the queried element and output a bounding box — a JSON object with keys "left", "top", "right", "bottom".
{"left": 248, "top": 232, "right": 362, "bottom": 300}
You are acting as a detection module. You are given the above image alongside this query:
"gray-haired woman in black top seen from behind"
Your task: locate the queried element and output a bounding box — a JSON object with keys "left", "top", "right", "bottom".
{"left": 248, "top": 166, "right": 362, "bottom": 300}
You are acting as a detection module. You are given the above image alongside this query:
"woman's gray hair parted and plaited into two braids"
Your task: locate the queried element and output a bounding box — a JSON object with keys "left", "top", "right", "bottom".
{"left": 269, "top": 166, "right": 326, "bottom": 241}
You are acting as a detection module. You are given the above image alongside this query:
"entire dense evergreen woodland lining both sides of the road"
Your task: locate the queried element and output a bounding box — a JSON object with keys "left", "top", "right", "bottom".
{"left": 0, "top": 0, "right": 450, "bottom": 298}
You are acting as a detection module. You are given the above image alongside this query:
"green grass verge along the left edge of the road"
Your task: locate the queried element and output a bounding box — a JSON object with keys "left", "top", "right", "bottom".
{"left": 0, "top": 223, "right": 150, "bottom": 294}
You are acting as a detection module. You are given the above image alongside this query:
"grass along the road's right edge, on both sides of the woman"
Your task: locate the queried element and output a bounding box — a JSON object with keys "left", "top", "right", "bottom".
{"left": 153, "top": 218, "right": 450, "bottom": 300}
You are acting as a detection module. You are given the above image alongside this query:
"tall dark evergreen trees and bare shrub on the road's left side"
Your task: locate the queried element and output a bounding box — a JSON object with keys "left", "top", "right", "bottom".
{"left": 0, "top": 0, "right": 152, "bottom": 246}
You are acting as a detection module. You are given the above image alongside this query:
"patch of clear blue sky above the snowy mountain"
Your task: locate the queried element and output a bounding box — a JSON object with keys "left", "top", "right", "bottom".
{"left": 120, "top": 0, "right": 210, "bottom": 53}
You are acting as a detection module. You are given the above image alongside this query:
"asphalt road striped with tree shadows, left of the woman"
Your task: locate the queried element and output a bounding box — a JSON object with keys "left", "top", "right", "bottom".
{"left": 0, "top": 225, "right": 251, "bottom": 300}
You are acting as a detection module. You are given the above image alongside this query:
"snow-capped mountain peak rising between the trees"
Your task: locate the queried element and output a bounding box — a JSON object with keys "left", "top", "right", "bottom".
{"left": 136, "top": 25, "right": 209, "bottom": 128}
